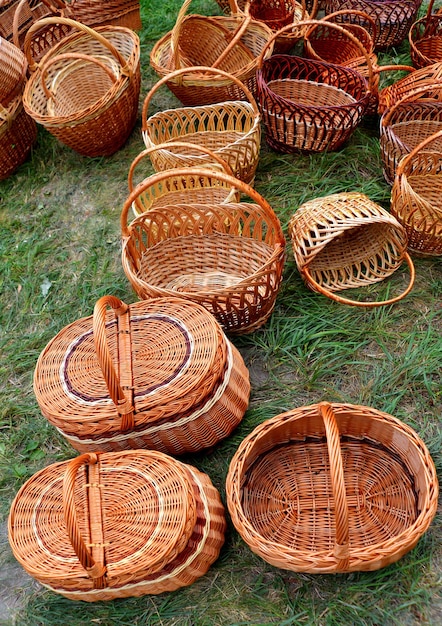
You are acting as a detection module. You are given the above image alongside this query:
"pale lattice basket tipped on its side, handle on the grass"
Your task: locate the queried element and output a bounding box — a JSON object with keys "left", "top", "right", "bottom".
{"left": 289, "top": 192, "right": 414, "bottom": 307}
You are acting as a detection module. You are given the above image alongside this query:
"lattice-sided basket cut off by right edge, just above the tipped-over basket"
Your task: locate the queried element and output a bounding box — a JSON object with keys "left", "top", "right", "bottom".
{"left": 391, "top": 130, "right": 442, "bottom": 256}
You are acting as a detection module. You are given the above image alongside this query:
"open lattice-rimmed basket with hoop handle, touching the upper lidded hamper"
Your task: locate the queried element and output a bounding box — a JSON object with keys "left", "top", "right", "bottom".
{"left": 121, "top": 168, "right": 285, "bottom": 333}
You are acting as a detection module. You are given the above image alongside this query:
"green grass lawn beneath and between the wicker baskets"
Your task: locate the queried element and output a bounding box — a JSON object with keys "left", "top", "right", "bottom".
{"left": 0, "top": 0, "right": 442, "bottom": 626}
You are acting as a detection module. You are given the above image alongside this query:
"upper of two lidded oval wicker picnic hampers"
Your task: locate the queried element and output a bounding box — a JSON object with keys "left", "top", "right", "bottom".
{"left": 34, "top": 296, "right": 250, "bottom": 455}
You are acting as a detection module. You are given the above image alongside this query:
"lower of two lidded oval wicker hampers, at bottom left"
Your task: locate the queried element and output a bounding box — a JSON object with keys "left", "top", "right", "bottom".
{"left": 9, "top": 450, "right": 226, "bottom": 602}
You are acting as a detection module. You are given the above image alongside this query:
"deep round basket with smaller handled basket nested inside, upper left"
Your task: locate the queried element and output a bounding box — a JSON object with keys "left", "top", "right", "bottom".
{"left": 23, "top": 17, "right": 141, "bottom": 157}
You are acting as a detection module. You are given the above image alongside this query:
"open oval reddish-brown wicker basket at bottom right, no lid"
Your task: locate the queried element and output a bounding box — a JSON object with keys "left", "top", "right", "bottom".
{"left": 226, "top": 402, "right": 438, "bottom": 574}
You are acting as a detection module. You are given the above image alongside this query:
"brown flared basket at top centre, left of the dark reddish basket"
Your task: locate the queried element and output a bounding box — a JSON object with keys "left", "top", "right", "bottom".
{"left": 150, "top": 0, "right": 273, "bottom": 106}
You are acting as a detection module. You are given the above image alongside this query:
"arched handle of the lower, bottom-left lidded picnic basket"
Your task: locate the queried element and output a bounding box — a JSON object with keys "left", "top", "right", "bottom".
{"left": 63, "top": 453, "right": 107, "bottom": 589}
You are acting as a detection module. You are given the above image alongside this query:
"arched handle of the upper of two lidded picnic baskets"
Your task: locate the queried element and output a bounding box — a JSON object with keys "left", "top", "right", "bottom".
{"left": 92, "top": 296, "right": 134, "bottom": 432}
